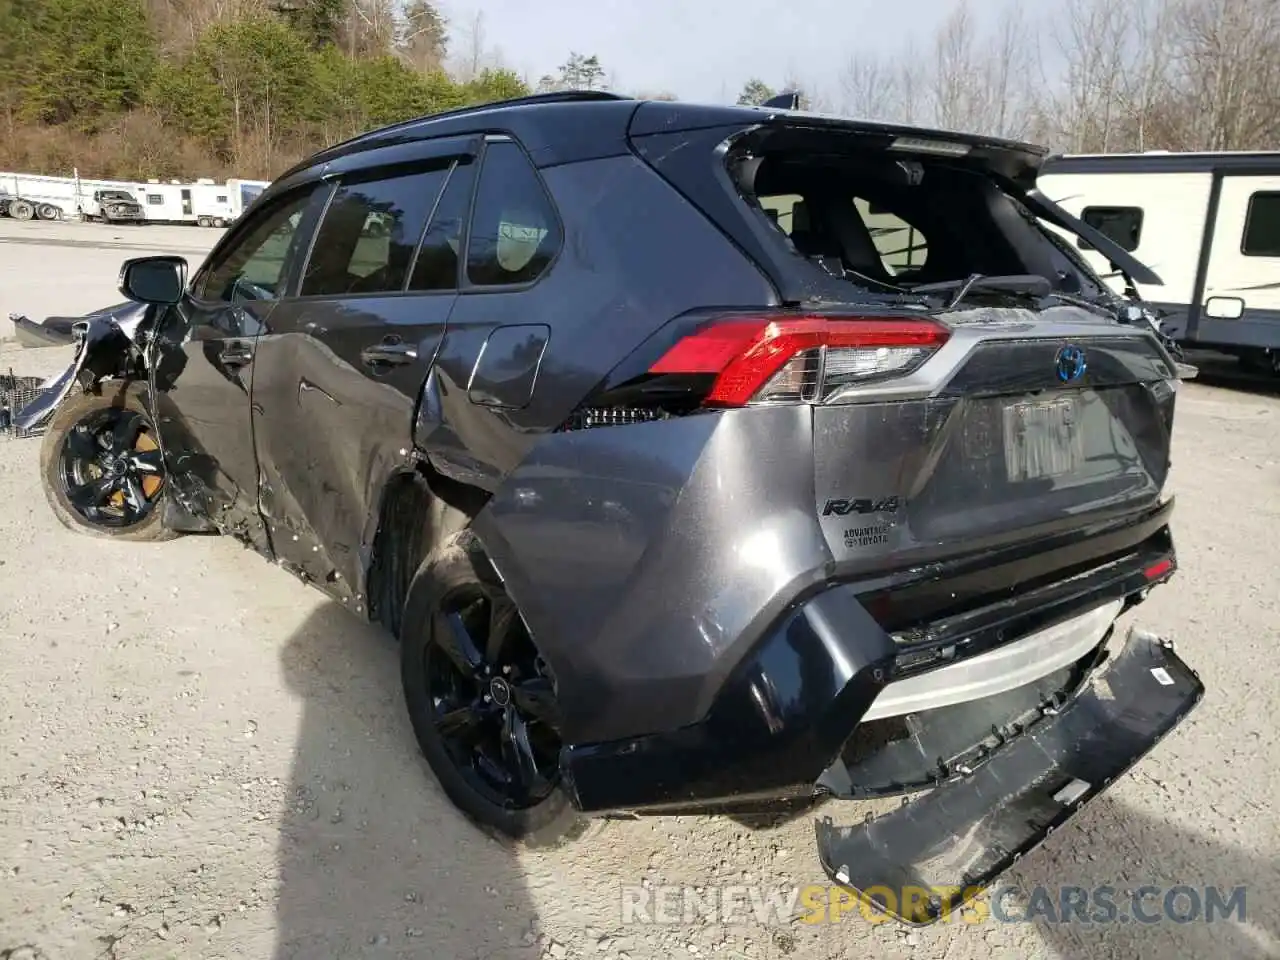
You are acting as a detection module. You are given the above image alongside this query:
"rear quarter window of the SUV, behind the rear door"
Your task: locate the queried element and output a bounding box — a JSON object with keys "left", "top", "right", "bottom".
{"left": 467, "top": 141, "right": 561, "bottom": 287}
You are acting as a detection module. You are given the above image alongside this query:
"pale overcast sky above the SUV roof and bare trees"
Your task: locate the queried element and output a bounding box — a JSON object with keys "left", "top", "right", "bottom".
{"left": 440, "top": 0, "right": 972, "bottom": 101}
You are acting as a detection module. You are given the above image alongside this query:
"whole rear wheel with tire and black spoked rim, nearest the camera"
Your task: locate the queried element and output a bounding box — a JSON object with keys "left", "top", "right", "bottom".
{"left": 401, "top": 530, "right": 590, "bottom": 846}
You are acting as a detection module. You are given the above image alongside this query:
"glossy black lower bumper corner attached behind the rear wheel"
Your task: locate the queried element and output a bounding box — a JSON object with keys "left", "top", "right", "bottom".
{"left": 561, "top": 588, "right": 897, "bottom": 814}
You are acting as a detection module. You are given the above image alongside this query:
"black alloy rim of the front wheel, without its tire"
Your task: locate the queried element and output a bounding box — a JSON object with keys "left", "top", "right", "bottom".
{"left": 58, "top": 406, "right": 164, "bottom": 529}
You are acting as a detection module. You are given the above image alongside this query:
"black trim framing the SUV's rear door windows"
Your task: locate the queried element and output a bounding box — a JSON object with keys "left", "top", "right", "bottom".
{"left": 288, "top": 134, "right": 483, "bottom": 303}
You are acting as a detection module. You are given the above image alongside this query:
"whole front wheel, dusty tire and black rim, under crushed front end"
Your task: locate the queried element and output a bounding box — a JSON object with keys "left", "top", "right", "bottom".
{"left": 40, "top": 384, "right": 175, "bottom": 540}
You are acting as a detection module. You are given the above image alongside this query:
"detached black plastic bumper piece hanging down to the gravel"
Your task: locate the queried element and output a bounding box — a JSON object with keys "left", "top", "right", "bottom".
{"left": 817, "top": 631, "right": 1204, "bottom": 925}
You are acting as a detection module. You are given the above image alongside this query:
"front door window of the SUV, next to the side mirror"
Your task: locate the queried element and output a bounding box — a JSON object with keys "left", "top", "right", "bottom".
{"left": 196, "top": 189, "right": 325, "bottom": 303}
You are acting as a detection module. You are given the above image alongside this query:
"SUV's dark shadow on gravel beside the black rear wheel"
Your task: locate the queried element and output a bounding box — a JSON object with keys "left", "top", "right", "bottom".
{"left": 274, "top": 604, "right": 538, "bottom": 960}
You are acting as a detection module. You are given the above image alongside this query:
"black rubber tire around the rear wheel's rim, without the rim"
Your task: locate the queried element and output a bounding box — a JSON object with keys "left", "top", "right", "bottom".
{"left": 399, "top": 530, "right": 599, "bottom": 847}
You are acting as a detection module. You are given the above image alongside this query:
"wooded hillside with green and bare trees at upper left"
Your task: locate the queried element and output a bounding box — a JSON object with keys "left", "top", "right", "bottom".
{"left": 0, "top": 0, "right": 581, "bottom": 179}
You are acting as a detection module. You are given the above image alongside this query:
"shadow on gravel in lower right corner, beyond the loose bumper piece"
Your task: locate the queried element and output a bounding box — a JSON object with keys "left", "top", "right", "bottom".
{"left": 1003, "top": 796, "right": 1280, "bottom": 960}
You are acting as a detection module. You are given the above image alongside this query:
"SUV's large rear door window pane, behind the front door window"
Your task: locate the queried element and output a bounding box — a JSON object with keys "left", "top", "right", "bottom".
{"left": 300, "top": 163, "right": 448, "bottom": 297}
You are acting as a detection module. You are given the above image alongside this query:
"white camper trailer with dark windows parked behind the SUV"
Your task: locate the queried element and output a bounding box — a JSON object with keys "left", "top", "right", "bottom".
{"left": 1037, "top": 152, "right": 1280, "bottom": 372}
